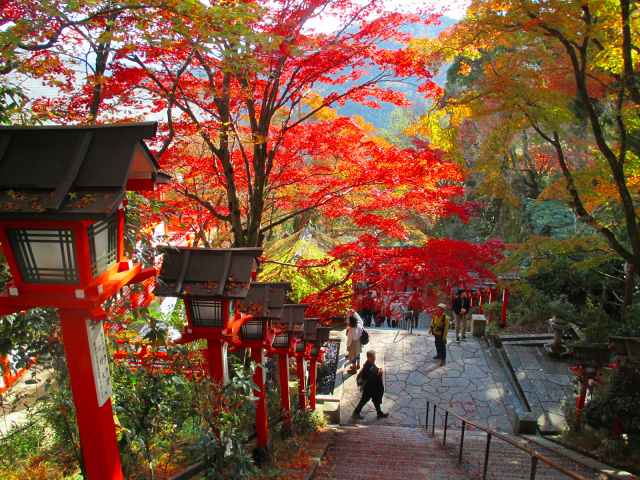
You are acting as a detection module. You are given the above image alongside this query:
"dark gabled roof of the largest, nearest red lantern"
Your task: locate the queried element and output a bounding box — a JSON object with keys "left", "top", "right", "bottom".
{"left": 0, "top": 122, "right": 169, "bottom": 219}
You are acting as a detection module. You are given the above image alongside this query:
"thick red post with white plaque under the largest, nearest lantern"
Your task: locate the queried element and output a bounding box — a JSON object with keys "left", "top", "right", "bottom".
{"left": 60, "top": 310, "right": 124, "bottom": 480}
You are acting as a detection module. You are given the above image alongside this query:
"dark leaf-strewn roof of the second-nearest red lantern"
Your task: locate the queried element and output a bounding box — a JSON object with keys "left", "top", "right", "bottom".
{"left": 155, "top": 246, "right": 262, "bottom": 298}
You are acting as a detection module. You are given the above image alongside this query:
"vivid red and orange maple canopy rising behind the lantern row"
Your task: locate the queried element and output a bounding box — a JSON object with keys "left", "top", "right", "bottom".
{"left": 1, "top": 0, "right": 500, "bottom": 316}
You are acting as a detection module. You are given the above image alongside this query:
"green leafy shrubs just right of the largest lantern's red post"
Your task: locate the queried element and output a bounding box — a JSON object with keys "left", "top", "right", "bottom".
{"left": 113, "top": 347, "right": 254, "bottom": 479}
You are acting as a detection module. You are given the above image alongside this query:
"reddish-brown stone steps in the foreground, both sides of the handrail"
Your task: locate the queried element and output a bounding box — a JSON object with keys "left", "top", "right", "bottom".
{"left": 312, "top": 424, "right": 634, "bottom": 480}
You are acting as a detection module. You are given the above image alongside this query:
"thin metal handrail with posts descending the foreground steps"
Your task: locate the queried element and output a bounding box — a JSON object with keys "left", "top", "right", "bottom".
{"left": 425, "top": 399, "right": 588, "bottom": 480}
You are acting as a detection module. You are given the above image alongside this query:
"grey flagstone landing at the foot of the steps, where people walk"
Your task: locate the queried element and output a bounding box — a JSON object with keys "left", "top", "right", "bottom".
{"left": 336, "top": 328, "right": 511, "bottom": 431}
